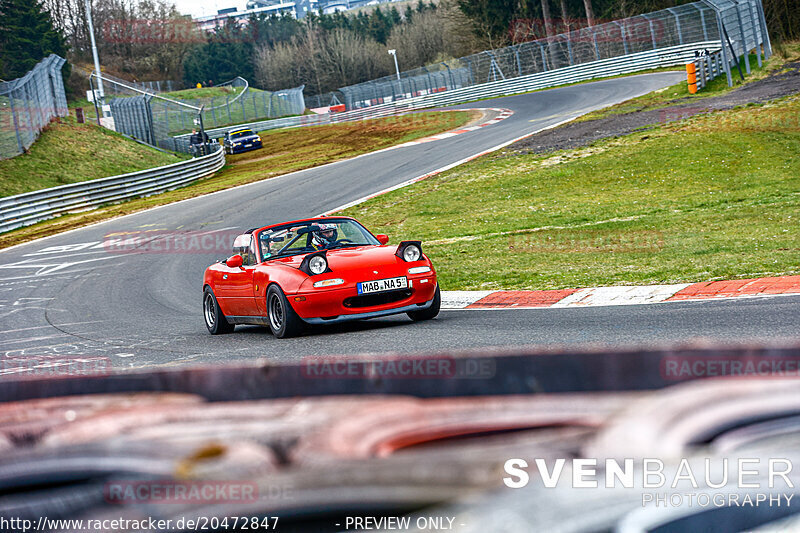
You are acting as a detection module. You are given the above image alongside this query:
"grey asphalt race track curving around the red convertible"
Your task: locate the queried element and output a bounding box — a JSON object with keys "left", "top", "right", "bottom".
{"left": 0, "top": 73, "right": 800, "bottom": 371}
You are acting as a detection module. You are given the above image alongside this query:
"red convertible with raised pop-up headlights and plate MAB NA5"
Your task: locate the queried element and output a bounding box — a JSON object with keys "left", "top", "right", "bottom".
{"left": 203, "top": 217, "right": 441, "bottom": 338}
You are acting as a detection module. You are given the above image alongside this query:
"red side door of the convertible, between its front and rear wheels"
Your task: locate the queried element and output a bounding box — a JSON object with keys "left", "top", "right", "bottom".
{"left": 216, "top": 233, "right": 258, "bottom": 316}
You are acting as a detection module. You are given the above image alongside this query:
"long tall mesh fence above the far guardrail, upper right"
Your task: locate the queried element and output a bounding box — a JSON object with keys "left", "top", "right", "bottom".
{"left": 306, "top": 0, "right": 769, "bottom": 110}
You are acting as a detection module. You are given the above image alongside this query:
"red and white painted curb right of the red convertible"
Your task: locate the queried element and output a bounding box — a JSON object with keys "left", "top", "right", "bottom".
{"left": 442, "top": 276, "right": 800, "bottom": 309}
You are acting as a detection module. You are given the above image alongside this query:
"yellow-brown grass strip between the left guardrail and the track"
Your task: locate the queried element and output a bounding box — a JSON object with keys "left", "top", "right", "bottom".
{"left": 0, "top": 111, "right": 476, "bottom": 248}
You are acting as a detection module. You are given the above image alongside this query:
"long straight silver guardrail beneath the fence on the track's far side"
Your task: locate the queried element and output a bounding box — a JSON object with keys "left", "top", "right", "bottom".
{"left": 174, "top": 41, "right": 721, "bottom": 146}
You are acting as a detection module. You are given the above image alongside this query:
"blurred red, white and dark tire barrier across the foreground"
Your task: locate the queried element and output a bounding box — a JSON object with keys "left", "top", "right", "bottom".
{"left": 0, "top": 346, "right": 800, "bottom": 533}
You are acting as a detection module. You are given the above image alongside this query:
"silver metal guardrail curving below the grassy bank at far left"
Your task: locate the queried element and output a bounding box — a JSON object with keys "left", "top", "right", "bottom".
{"left": 0, "top": 147, "right": 225, "bottom": 233}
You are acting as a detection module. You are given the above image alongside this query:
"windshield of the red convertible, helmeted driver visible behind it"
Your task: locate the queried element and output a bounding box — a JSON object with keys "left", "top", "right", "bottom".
{"left": 258, "top": 219, "right": 380, "bottom": 260}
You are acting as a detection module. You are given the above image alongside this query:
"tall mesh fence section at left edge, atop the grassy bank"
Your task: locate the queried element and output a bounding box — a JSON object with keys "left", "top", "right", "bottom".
{"left": 0, "top": 54, "right": 69, "bottom": 159}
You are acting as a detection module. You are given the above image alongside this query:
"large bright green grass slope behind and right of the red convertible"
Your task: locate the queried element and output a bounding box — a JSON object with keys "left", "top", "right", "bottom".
{"left": 345, "top": 93, "right": 800, "bottom": 290}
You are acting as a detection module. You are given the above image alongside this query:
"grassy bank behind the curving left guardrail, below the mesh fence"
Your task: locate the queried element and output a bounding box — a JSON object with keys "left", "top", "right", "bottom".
{"left": 0, "top": 115, "right": 183, "bottom": 196}
